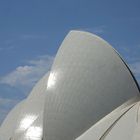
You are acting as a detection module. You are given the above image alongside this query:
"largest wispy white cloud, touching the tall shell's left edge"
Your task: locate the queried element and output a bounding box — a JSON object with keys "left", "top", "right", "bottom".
{"left": 0, "top": 55, "right": 53, "bottom": 94}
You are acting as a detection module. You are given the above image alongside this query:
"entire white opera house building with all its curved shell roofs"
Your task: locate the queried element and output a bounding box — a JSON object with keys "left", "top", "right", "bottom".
{"left": 0, "top": 31, "right": 140, "bottom": 140}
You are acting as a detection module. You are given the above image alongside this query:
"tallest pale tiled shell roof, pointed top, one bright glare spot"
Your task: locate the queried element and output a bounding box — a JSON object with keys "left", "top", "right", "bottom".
{"left": 43, "top": 31, "right": 139, "bottom": 140}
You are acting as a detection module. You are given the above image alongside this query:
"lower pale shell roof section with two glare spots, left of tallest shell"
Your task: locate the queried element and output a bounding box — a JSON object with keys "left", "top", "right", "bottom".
{"left": 0, "top": 73, "right": 49, "bottom": 140}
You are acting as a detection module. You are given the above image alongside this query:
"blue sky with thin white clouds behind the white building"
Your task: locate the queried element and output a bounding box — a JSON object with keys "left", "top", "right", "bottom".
{"left": 0, "top": 0, "right": 140, "bottom": 123}
